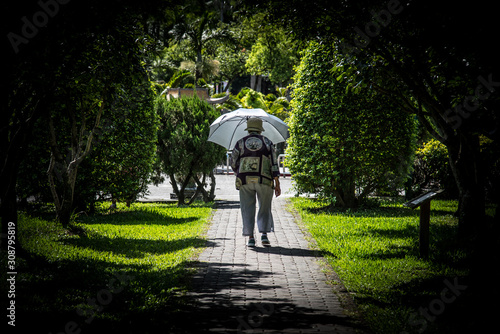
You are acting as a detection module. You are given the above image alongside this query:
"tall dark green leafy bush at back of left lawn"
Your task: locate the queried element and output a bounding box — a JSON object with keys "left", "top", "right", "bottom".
{"left": 75, "top": 83, "right": 159, "bottom": 209}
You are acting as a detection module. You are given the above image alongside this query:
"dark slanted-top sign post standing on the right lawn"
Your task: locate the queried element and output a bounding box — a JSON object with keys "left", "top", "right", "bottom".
{"left": 404, "top": 189, "right": 444, "bottom": 258}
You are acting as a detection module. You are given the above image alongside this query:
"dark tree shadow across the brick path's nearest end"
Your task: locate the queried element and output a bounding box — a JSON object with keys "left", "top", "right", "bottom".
{"left": 172, "top": 262, "right": 364, "bottom": 334}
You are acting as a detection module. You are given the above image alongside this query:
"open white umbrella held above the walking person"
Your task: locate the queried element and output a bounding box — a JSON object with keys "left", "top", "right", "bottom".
{"left": 208, "top": 108, "right": 289, "bottom": 150}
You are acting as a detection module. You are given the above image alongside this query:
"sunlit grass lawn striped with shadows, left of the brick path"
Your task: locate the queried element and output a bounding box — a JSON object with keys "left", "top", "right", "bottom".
{"left": 2, "top": 203, "right": 212, "bottom": 333}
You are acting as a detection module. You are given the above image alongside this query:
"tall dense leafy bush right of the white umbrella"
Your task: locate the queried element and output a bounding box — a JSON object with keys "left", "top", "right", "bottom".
{"left": 286, "top": 43, "right": 415, "bottom": 207}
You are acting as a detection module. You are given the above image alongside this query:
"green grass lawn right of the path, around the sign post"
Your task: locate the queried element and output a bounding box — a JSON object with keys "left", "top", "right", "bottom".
{"left": 292, "top": 198, "right": 482, "bottom": 334}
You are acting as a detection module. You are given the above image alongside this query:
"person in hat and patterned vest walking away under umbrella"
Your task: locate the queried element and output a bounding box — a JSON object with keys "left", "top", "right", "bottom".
{"left": 231, "top": 117, "right": 281, "bottom": 247}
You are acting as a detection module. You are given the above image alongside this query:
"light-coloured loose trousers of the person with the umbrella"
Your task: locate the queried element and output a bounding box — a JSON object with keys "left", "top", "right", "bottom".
{"left": 240, "top": 183, "right": 274, "bottom": 236}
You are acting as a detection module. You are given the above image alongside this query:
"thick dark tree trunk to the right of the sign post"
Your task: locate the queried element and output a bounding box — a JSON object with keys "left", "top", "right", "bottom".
{"left": 448, "top": 136, "right": 485, "bottom": 238}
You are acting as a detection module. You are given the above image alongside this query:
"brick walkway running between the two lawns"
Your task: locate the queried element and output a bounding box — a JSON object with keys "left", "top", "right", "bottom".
{"left": 176, "top": 197, "right": 372, "bottom": 333}
